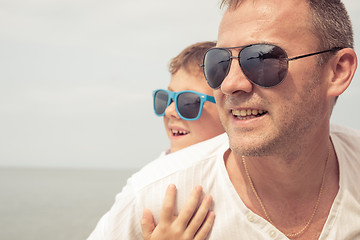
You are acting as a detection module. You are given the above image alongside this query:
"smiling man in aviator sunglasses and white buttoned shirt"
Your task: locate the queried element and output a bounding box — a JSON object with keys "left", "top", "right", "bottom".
{"left": 89, "top": 0, "right": 360, "bottom": 239}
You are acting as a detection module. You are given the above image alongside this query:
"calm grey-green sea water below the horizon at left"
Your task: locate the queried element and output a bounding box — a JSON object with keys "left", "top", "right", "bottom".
{"left": 0, "top": 168, "right": 136, "bottom": 240}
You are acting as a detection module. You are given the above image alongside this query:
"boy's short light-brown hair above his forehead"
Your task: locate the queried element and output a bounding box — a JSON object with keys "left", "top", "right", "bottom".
{"left": 169, "top": 41, "right": 216, "bottom": 75}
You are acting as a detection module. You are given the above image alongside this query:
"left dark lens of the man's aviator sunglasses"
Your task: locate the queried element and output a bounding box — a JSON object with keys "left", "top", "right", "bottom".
{"left": 204, "top": 48, "right": 230, "bottom": 89}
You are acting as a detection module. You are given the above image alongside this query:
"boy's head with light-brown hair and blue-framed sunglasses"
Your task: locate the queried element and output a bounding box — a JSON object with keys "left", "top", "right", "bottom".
{"left": 154, "top": 42, "right": 224, "bottom": 152}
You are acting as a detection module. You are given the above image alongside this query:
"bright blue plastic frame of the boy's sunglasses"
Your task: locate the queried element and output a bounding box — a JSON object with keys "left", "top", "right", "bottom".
{"left": 153, "top": 89, "right": 215, "bottom": 121}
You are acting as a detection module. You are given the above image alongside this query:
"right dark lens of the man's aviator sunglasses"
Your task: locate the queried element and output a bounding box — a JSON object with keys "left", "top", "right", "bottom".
{"left": 239, "top": 44, "right": 288, "bottom": 87}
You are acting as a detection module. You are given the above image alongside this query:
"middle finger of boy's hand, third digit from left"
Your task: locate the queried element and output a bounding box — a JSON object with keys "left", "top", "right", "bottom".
{"left": 176, "top": 186, "right": 202, "bottom": 228}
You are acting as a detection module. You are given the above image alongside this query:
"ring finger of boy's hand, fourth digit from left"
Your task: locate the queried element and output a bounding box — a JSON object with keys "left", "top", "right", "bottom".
{"left": 186, "top": 195, "right": 212, "bottom": 236}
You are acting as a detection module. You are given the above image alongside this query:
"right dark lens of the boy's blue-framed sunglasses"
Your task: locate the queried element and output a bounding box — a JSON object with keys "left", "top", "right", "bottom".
{"left": 177, "top": 92, "right": 201, "bottom": 119}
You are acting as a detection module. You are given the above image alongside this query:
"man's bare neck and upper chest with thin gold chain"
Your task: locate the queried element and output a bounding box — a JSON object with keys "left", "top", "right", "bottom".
{"left": 225, "top": 136, "right": 339, "bottom": 239}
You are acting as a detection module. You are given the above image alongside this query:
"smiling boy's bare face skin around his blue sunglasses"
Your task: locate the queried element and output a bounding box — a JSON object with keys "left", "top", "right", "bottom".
{"left": 164, "top": 69, "right": 224, "bottom": 152}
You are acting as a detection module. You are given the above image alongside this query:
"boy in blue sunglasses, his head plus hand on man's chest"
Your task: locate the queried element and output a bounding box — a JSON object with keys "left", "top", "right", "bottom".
{"left": 141, "top": 42, "right": 224, "bottom": 240}
